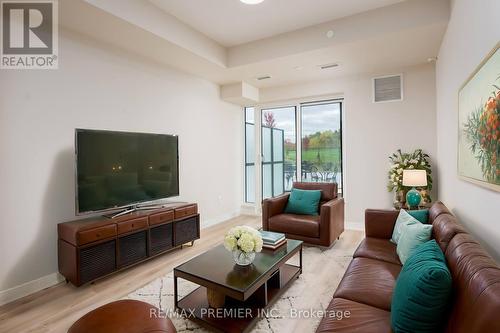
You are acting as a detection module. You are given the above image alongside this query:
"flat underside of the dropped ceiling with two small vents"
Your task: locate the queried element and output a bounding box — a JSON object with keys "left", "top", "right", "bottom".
{"left": 225, "top": 25, "right": 446, "bottom": 88}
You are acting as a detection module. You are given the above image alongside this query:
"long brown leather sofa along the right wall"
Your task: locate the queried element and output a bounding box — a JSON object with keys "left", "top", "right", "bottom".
{"left": 316, "top": 202, "right": 500, "bottom": 333}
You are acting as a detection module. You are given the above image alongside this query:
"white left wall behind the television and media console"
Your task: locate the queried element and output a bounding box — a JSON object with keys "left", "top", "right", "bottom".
{"left": 0, "top": 31, "right": 243, "bottom": 301}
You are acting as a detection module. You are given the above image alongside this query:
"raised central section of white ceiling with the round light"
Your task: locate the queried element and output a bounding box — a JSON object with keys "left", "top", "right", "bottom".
{"left": 150, "top": 0, "right": 405, "bottom": 47}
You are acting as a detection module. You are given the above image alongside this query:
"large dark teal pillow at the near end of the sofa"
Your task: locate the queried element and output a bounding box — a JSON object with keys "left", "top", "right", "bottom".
{"left": 391, "top": 240, "right": 452, "bottom": 333}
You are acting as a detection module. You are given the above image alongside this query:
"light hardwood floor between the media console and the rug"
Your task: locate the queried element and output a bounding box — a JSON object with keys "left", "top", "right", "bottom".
{"left": 0, "top": 215, "right": 361, "bottom": 333}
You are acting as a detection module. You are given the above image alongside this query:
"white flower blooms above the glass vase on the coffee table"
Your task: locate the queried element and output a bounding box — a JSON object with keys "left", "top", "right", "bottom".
{"left": 224, "top": 226, "right": 262, "bottom": 253}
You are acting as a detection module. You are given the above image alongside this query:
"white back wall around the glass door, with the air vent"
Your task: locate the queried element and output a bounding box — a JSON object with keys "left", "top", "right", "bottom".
{"left": 261, "top": 64, "right": 436, "bottom": 228}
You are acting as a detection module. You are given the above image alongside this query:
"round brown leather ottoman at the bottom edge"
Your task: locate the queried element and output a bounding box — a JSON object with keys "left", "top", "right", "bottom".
{"left": 68, "top": 300, "right": 177, "bottom": 333}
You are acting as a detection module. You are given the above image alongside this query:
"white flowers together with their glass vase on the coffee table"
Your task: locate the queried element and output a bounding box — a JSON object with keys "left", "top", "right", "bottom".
{"left": 224, "top": 226, "right": 263, "bottom": 266}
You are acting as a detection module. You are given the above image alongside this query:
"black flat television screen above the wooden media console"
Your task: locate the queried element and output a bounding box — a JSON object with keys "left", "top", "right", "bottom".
{"left": 76, "top": 129, "right": 179, "bottom": 214}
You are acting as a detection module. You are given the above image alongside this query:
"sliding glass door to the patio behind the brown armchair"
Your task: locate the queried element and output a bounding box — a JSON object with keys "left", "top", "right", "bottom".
{"left": 245, "top": 100, "right": 343, "bottom": 203}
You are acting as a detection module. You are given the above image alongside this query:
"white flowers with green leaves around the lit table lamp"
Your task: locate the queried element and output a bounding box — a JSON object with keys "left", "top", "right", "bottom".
{"left": 387, "top": 149, "right": 432, "bottom": 208}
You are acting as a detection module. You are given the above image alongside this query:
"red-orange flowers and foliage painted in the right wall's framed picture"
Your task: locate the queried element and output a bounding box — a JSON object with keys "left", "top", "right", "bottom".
{"left": 463, "top": 83, "right": 500, "bottom": 184}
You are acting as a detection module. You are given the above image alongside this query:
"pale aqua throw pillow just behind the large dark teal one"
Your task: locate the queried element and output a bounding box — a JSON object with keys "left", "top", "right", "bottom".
{"left": 396, "top": 222, "right": 432, "bottom": 265}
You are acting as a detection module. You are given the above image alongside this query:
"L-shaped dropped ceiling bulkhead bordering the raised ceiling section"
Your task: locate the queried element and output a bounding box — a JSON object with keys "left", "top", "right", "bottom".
{"left": 63, "top": 0, "right": 449, "bottom": 93}
